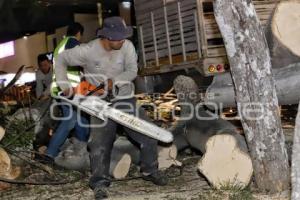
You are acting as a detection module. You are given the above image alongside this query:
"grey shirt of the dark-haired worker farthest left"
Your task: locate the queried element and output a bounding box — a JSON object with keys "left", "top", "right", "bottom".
{"left": 35, "top": 69, "right": 52, "bottom": 98}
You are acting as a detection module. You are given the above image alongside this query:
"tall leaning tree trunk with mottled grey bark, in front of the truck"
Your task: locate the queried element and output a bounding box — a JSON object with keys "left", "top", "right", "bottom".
{"left": 214, "top": 0, "right": 290, "bottom": 193}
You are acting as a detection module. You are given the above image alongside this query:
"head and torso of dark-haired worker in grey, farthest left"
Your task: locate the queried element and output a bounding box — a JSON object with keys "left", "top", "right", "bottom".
{"left": 35, "top": 54, "right": 52, "bottom": 99}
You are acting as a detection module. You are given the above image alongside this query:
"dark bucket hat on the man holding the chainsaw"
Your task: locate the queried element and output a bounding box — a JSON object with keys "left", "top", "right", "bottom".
{"left": 97, "top": 17, "right": 132, "bottom": 40}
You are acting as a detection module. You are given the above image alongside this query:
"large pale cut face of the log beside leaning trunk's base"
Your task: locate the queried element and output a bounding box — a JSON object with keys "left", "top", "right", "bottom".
{"left": 198, "top": 134, "right": 253, "bottom": 189}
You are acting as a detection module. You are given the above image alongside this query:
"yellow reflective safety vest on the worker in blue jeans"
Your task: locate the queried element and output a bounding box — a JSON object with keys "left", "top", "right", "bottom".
{"left": 51, "top": 37, "right": 80, "bottom": 97}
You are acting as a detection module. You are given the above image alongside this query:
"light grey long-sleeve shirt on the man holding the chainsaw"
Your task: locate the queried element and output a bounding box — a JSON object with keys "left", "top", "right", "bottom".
{"left": 55, "top": 39, "right": 138, "bottom": 99}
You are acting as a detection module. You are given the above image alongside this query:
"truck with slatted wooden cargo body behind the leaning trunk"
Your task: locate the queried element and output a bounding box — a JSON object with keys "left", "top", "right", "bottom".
{"left": 134, "top": 0, "right": 280, "bottom": 76}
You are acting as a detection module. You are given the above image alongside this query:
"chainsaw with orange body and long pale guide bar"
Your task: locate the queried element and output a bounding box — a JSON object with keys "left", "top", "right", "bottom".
{"left": 57, "top": 81, "right": 173, "bottom": 143}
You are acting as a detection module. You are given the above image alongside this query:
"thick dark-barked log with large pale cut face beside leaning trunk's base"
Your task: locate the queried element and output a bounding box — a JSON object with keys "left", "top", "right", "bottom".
{"left": 186, "top": 108, "right": 253, "bottom": 188}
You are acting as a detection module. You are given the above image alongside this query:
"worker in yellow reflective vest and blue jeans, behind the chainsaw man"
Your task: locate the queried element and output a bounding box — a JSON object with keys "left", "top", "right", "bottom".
{"left": 44, "top": 23, "right": 89, "bottom": 162}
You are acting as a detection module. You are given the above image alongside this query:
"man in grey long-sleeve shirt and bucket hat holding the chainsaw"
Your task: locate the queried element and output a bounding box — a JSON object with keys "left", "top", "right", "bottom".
{"left": 55, "top": 17, "right": 167, "bottom": 199}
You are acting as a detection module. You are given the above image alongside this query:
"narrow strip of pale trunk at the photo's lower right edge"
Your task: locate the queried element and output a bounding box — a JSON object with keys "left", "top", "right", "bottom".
{"left": 292, "top": 104, "right": 300, "bottom": 200}
